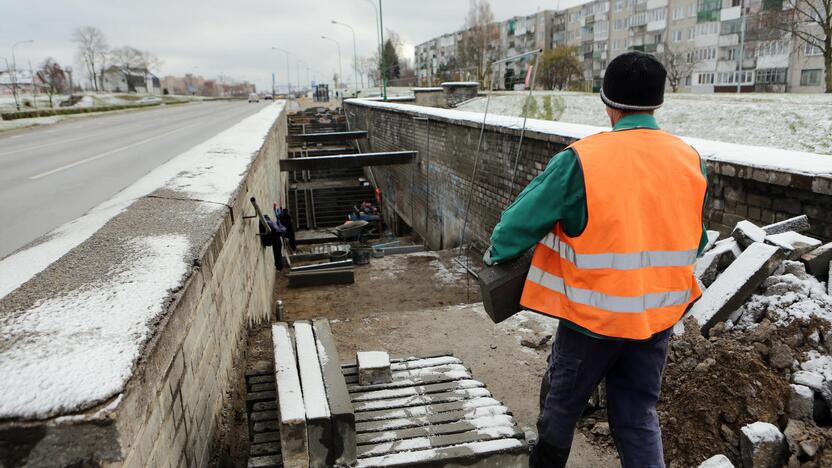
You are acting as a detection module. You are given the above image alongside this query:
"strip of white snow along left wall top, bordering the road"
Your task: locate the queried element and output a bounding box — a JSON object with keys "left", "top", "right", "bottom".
{"left": 0, "top": 101, "right": 285, "bottom": 298}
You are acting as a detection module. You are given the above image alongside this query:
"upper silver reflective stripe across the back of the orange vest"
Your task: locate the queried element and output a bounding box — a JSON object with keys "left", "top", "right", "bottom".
{"left": 540, "top": 232, "right": 699, "bottom": 270}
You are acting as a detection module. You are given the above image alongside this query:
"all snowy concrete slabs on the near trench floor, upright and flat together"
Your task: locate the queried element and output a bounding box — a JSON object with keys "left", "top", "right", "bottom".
{"left": 270, "top": 319, "right": 528, "bottom": 467}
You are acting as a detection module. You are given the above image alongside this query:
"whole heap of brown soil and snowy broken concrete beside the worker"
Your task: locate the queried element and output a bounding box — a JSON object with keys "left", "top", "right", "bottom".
{"left": 581, "top": 216, "right": 832, "bottom": 467}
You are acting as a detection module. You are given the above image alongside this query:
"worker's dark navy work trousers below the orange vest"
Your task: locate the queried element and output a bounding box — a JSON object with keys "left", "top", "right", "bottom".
{"left": 532, "top": 326, "right": 671, "bottom": 468}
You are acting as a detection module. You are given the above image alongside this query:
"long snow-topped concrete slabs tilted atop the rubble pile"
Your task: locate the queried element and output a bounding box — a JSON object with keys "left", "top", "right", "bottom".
{"left": 676, "top": 216, "right": 832, "bottom": 336}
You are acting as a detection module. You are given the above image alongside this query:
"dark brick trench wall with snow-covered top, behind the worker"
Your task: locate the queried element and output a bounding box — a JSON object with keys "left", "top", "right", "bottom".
{"left": 344, "top": 100, "right": 832, "bottom": 249}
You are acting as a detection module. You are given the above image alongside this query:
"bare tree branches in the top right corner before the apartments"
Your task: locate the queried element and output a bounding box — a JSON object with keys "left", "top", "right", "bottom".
{"left": 775, "top": 0, "right": 832, "bottom": 93}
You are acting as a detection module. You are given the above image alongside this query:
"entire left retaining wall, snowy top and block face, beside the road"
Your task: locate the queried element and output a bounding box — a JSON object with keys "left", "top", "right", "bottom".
{"left": 0, "top": 102, "right": 286, "bottom": 467}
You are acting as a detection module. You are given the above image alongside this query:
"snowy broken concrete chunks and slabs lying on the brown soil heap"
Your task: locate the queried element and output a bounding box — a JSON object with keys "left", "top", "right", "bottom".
{"left": 680, "top": 216, "right": 832, "bottom": 467}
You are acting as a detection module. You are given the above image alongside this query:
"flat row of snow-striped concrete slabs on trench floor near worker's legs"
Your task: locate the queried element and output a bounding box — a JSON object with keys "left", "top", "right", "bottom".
{"left": 343, "top": 355, "right": 528, "bottom": 467}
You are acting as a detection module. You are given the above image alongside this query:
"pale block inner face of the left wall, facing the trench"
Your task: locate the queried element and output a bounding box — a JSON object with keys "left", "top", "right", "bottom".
{"left": 117, "top": 112, "right": 287, "bottom": 467}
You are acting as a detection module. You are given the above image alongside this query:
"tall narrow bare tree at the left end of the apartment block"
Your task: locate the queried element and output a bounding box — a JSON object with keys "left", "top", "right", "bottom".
{"left": 457, "top": 0, "right": 499, "bottom": 81}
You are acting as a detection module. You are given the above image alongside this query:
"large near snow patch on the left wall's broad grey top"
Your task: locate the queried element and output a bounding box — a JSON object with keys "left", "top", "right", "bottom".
{"left": 0, "top": 235, "right": 189, "bottom": 418}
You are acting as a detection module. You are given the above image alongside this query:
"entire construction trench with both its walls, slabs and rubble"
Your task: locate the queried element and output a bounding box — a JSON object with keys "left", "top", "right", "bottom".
{"left": 0, "top": 96, "right": 832, "bottom": 467}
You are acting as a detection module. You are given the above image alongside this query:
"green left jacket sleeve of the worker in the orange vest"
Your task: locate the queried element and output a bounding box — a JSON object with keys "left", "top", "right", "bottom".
{"left": 485, "top": 149, "right": 587, "bottom": 264}
